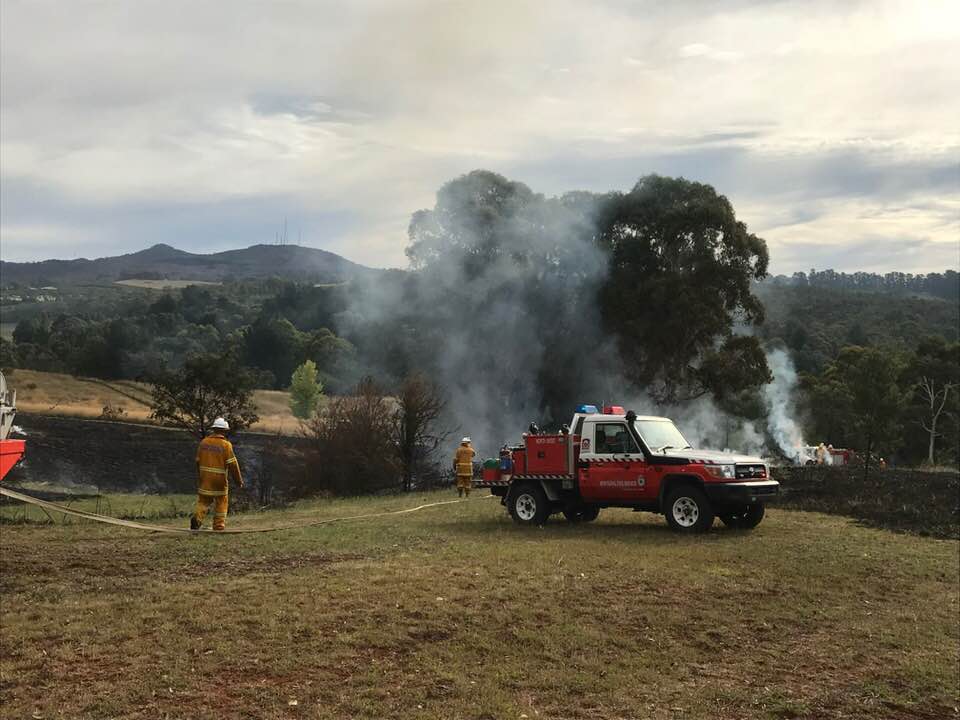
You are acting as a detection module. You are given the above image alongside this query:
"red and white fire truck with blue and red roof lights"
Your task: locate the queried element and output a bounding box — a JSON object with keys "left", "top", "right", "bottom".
{"left": 474, "top": 405, "right": 780, "bottom": 532}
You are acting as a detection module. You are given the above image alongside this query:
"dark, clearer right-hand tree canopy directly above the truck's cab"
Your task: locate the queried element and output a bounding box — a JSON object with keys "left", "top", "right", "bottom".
{"left": 599, "top": 175, "right": 771, "bottom": 401}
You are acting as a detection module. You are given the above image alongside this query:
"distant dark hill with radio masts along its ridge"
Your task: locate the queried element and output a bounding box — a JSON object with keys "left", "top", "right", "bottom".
{"left": 0, "top": 244, "right": 378, "bottom": 287}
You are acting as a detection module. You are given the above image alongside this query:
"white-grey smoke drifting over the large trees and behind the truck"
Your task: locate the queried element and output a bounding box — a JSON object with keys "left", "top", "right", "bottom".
{"left": 340, "top": 171, "right": 803, "bottom": 458}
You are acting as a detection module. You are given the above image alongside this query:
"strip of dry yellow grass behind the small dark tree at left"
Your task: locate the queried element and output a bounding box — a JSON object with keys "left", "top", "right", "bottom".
{"left": 7, "top": 370, "right": 300, "bottom": 435}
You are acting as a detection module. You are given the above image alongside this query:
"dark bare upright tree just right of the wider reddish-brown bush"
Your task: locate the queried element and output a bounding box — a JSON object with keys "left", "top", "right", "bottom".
{"left": 393, "top": 373, "right": 450, "bottom": 492}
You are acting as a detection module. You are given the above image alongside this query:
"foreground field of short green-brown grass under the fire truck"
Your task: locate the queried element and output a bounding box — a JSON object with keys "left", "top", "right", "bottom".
{"left": 0, "top": 493, "right": 960, "bottom": 720}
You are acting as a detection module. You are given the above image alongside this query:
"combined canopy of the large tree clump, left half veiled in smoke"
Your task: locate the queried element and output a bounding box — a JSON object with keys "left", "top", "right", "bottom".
{"left": 397, "top": 171, "right": 770, "bottom": 434}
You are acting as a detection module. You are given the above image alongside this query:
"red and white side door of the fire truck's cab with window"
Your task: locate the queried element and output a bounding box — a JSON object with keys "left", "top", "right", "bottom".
{"left": 578, "top": 420, "right": 647, "bottom": 504}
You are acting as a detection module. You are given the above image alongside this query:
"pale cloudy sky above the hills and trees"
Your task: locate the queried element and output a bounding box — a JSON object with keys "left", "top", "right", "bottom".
{"left": 0, "top": 0, "right": 960, "bottom": 273}
